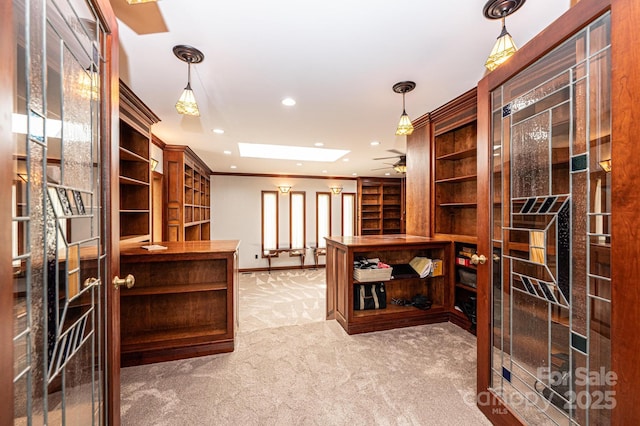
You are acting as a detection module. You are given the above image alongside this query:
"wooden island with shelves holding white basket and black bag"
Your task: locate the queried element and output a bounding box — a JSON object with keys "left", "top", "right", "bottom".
{"left": 326, "top": 234, "right": 453, "bottom": 334}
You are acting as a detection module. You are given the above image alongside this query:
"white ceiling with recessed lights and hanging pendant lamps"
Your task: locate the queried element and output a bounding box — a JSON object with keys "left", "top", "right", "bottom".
{"left": 112, "top": 0, "right": 569, "bottom": 177}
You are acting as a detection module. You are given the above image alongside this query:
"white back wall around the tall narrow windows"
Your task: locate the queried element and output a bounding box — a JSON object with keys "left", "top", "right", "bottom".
{"left": 211, "top": 175, "right": 357, "bottom": 269}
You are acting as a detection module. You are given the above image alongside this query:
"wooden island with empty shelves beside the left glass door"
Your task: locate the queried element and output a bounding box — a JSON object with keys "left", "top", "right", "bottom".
{"left": 120, "top": 240, "right": 239, "bottom": 366}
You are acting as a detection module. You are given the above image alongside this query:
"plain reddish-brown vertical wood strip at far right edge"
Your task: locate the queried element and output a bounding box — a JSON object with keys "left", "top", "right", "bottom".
{"left": 608, "top": 0, "right": 640, "bottom": 425}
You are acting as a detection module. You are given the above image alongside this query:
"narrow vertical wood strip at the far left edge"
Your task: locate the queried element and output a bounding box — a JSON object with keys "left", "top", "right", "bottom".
{"left": 0, "top": 1, "right": 17, "bottom": 426}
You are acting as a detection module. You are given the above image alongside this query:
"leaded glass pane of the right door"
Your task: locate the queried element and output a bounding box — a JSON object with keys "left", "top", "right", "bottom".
{"left": 490, "top": 13, "right": 617, "bottom": 425}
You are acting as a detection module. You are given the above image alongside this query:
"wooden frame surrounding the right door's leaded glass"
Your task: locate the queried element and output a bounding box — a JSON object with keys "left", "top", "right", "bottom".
{"left": 477, "top": 0, "right": 640, "bottom": 425}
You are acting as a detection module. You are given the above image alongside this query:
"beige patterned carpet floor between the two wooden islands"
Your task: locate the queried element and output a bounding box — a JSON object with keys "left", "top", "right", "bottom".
{"left": 121, "top": 270, "right": 490, "bottom": 426}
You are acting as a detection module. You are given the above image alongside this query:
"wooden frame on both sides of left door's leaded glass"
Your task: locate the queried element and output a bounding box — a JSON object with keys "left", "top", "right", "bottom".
{"left": 0, "top": 0, "right": 120, "bottom": 426}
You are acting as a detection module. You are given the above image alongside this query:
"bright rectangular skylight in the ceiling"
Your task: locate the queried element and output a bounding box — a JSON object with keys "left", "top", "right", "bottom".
{"left": 238, "top": 143, "right": 351, "bottom": 162}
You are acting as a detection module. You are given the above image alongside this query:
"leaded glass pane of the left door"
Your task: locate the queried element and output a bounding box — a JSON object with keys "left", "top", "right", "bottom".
{"left": 10, "top": 0, "right": 110, "bottom": 425}
